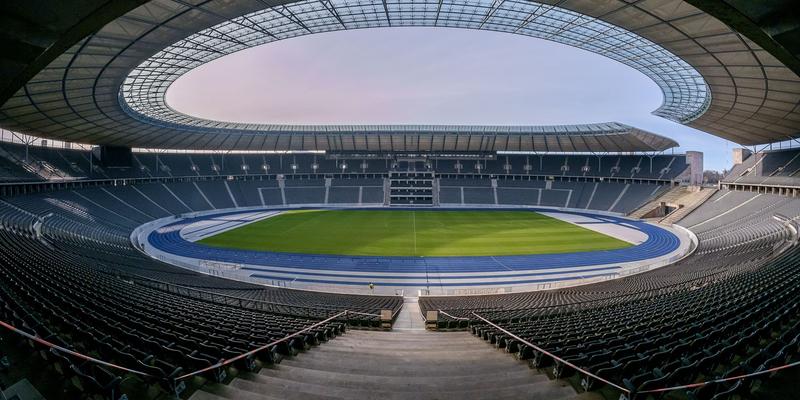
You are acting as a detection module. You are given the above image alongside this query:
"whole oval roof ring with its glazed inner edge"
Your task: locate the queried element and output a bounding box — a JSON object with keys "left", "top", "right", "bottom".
{"left": 0, "top": 0, "right": 800, "bottom": 151}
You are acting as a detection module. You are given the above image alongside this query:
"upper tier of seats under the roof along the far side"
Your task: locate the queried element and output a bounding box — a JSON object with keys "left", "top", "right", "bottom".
{"left": 0, "top": 142, "right": 687, "bottom": 181}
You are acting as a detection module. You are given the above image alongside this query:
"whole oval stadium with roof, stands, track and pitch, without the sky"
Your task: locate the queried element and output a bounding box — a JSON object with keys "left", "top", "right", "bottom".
{"left": 0, "top": 0, "right": 800, "bottom": 400}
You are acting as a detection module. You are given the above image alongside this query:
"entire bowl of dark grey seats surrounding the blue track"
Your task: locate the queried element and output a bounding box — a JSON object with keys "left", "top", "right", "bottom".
{"left": 0, "top": 145, "right": 764, "bottom": 398}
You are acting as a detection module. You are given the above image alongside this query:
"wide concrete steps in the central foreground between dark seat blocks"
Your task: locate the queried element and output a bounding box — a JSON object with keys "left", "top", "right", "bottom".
{"left": 190, "top": 330, "right": 600, "bottom": 400}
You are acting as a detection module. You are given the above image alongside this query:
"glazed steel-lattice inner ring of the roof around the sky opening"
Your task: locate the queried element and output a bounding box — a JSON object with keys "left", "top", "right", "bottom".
{"left": 121, "top": 0, "right": 710, "bottom": 142}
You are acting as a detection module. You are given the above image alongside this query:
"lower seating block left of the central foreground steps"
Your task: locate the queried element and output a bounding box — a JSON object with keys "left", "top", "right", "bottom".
{"left": 0, "top": 193, "right": 401, "bottom": 398}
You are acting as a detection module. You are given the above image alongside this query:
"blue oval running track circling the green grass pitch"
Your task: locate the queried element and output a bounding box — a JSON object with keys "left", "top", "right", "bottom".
{"left": 148, "top": 208, "right": 680, "bottom": 286}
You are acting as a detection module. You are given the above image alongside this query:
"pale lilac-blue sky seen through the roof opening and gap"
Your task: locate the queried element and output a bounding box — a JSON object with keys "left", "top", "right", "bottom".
{"left": 167, "top": 27, "right": 738, "bottom": 170}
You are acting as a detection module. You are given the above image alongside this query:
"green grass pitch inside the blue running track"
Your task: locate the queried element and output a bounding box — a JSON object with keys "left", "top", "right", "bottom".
{"left": 198, "top": 210, "right": 632, "bottom": 257}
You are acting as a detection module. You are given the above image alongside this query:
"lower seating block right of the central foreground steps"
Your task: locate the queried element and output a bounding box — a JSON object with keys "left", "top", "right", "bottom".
{"left": 420, "top": 191, "right": 800, "bottom": 399}
